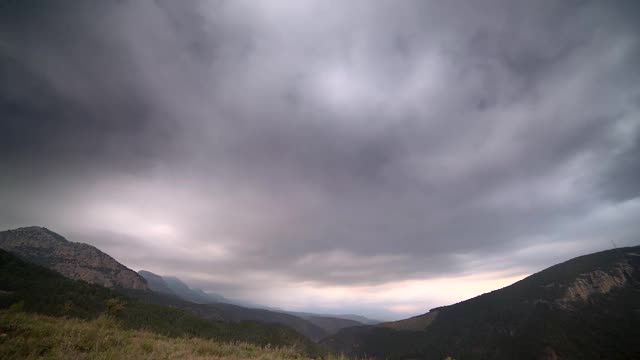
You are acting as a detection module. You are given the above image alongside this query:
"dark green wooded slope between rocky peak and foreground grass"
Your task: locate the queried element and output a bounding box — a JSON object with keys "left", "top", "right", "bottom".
{"left": 0, "top": 250, "right": 322, "bottom": 356}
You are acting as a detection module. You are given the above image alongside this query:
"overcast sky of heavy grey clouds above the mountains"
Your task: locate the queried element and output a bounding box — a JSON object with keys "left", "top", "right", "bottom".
{"left": 0, "top": 0, "right": 640, "bottom": 319}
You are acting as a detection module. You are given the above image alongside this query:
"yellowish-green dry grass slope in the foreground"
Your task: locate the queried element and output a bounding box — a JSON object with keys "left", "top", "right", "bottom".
{"left": 0, "top": 306, "right": 348, "bottom": 360}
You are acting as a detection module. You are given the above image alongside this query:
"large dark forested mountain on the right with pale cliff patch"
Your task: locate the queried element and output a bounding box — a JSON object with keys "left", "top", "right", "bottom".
{"left": 321, "top": 246, "right": 640, "bottom": 359}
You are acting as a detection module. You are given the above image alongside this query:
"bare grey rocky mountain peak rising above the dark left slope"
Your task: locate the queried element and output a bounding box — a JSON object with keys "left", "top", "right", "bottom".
{"left": 0, "top": 226, "right": 148, "bottom": 290}
